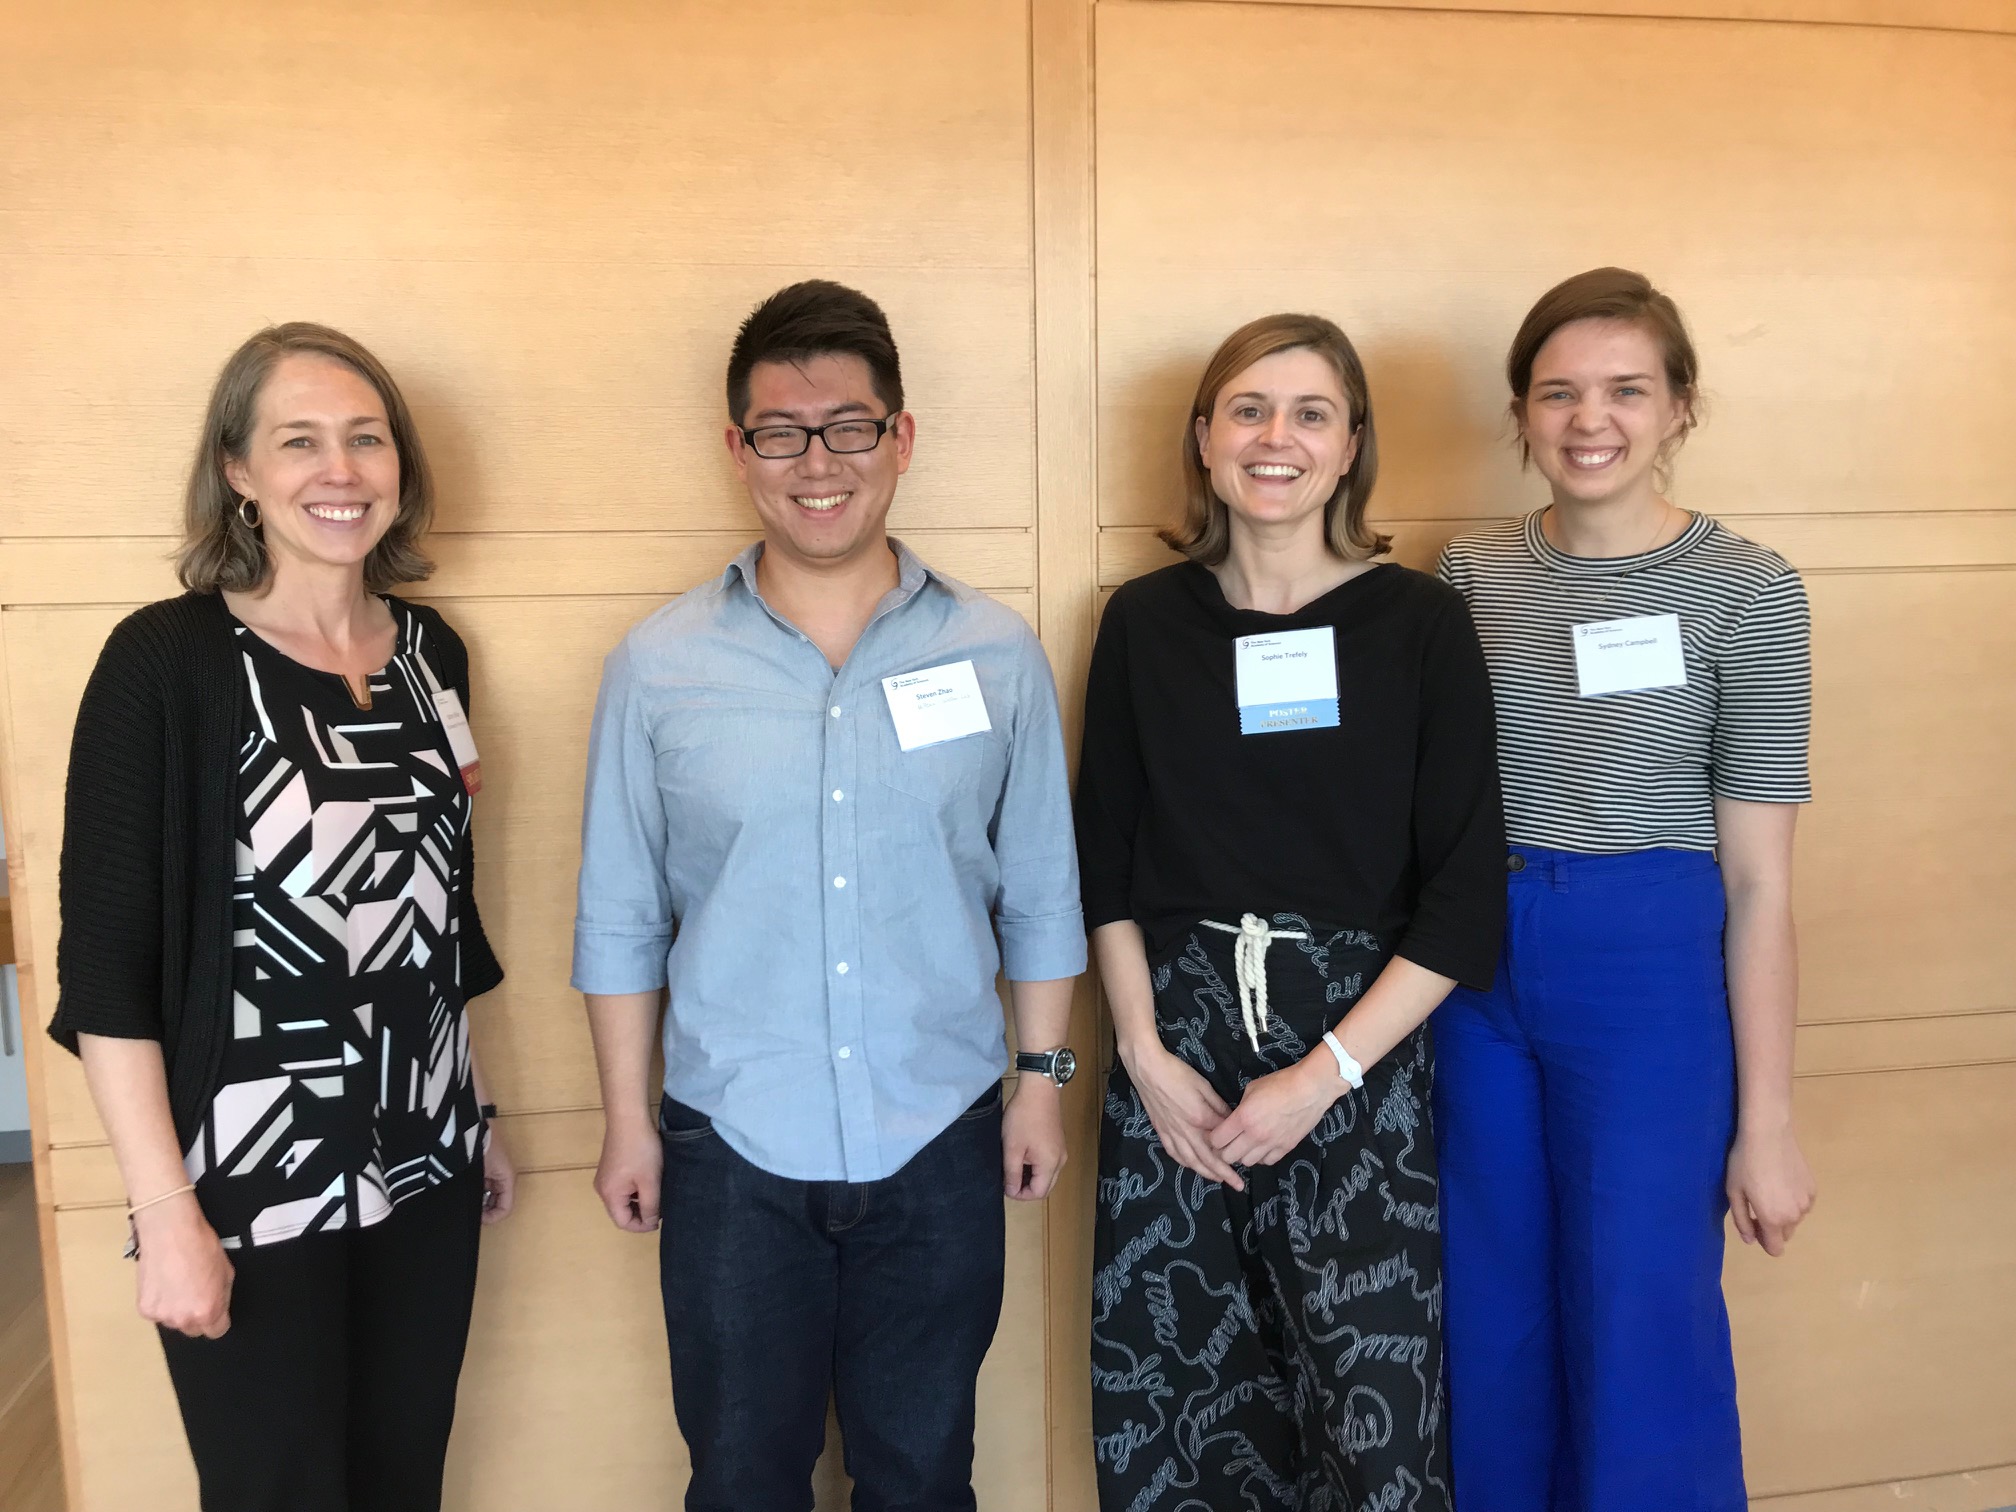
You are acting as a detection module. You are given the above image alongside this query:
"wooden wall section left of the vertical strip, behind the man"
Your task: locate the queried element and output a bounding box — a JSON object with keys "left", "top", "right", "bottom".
{"left": 0, "top": 0, "right": 1093, "bottom": 1512}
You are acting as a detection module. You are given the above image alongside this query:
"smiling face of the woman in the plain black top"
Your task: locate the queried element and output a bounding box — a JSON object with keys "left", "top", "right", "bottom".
{"left": 1195, "top": 347, "right": 1359, "bottom": 544}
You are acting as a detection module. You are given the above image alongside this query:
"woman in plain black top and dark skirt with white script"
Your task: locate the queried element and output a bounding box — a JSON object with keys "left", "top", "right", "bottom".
{"left": 1079, "top": 314, "right": 1504, "bottom": 1512}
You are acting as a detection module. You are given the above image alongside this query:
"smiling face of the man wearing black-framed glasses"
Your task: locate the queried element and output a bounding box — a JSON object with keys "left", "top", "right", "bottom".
{"left": 728, "top": 355, "right": 917, "bottom": 566}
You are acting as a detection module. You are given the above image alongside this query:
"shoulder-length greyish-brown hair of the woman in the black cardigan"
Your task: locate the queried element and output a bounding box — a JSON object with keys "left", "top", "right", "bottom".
{"left": 175, "top": 321, "right": 433, "bottom": 593}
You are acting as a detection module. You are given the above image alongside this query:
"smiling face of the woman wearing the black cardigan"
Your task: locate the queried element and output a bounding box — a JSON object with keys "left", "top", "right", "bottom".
{"left": 224, "top": 353, "right": 399, "bottom": 573}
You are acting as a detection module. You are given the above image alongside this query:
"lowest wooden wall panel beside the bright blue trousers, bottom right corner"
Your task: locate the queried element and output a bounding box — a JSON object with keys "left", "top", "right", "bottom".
{"left": 1726, "top": 1064, "right": 2016, "bottom": 1512}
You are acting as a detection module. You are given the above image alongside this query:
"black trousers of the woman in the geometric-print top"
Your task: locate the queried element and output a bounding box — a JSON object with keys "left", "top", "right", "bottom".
{"left": 161, "top": 1167, "right": 484, "bottom": 1512}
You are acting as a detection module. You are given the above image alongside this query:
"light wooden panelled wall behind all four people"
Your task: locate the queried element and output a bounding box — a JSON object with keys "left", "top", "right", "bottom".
{"left": 0, "top": 0, "right": 2016, "bottom": 1512}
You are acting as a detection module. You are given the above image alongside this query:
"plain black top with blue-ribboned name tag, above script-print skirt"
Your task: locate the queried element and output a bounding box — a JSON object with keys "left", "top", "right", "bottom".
{"left": 1079, "top": 562, "right": 1506, "bottom": 988}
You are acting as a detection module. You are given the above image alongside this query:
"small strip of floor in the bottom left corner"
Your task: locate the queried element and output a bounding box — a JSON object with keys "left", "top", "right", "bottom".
{"left": 0, "top": 1165, "right": 62, "bottom": 1512}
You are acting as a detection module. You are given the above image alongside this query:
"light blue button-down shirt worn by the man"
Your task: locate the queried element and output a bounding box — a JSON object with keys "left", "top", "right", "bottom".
{"left": 575, "top": 544, "right": 1085, "bottom": 1181}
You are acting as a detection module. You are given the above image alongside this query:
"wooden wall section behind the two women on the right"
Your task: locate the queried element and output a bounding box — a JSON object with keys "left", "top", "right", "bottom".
{"left": 1097, "top": 0, "right": 2016, "bottom": 1512}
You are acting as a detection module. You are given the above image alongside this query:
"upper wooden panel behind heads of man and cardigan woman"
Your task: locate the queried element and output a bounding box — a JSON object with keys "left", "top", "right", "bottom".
{"left": 0, "top": 0, "right": 1032, "bottom": 534}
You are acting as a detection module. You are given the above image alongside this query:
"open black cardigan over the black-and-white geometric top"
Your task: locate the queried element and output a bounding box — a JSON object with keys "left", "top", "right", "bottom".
{"left": 48, "top": 593, "right": 504, "bottom": 1143}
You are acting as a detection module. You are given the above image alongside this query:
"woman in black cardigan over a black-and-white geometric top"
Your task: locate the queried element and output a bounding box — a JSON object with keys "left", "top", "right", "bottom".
{"left": 50, "top": 325, "right": 512, "bottom": 1512}
